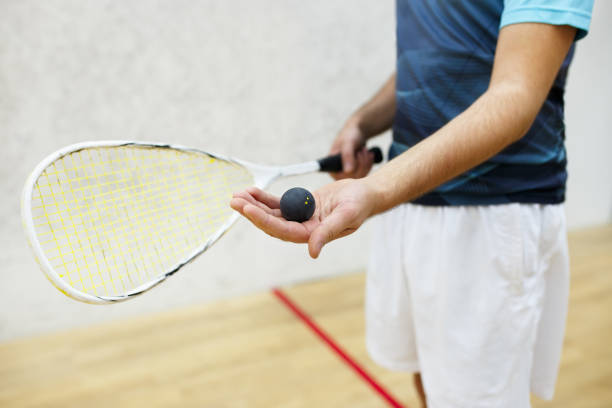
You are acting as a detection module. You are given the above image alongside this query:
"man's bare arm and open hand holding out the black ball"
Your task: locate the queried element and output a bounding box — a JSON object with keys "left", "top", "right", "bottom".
{"left": 231, "top": 23, "right": 576, "bottom": 258}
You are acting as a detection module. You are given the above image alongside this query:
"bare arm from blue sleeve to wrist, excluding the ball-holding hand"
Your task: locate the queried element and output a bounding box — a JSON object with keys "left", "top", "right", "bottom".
{"left": 365, "top": 23, "right": 576, "bottom": 213}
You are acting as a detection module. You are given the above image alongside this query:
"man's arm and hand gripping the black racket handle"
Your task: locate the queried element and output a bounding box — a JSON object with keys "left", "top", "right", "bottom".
{"left": 329, "top": 73, "right": 395, "bottom": 180}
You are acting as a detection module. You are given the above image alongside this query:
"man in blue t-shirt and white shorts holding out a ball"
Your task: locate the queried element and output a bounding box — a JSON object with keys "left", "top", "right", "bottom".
{"left": 231, "top": 0, "right": 593, "bottom": 408}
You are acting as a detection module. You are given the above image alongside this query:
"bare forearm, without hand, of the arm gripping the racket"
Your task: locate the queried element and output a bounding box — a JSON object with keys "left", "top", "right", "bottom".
{"left": 349, "top": 73, "right": 395, "bottom": 138}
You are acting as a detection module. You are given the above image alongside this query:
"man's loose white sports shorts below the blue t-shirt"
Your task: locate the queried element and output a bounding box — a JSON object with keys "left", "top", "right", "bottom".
{"left": 366, "top": 204, "right": 569, "bottom": 408}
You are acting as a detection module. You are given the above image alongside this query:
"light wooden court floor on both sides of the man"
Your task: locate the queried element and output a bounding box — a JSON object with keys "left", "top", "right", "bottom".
{"left": 0, "top": 226, "right": 612, "bottom": 408}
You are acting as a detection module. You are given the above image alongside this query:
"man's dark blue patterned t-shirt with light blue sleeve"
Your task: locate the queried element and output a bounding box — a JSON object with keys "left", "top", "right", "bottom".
{"left": 389, "top": 0, "right": 593, "bottom": 205}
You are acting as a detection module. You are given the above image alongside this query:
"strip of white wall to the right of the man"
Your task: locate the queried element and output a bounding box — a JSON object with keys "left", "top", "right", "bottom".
{"left": 565, "top": 0, "right": 612, "bottom": 228}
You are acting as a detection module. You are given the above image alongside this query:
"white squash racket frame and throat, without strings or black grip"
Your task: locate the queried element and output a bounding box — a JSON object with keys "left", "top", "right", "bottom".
{"left": 21, "top": 140, "right": 320, "bottom": 304}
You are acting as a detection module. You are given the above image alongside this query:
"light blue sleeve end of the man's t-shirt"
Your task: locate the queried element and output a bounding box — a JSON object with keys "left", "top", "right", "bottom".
{"left": 499, "top": 0, "right": 594, "bottom": 40}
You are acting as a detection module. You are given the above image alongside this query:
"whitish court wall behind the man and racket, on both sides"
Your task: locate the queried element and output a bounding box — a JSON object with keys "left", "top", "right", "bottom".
{"left": 0, "top": 0, "right": 612, "bottom": 340}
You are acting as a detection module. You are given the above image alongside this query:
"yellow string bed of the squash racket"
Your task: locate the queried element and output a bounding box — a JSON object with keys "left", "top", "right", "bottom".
{"left": 32, "top": 146, "right": 253, "bottom": 296}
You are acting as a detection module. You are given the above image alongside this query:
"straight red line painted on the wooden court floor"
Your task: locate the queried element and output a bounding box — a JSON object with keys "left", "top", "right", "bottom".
{"left": 272, "top": 289, "right": 407, "bottom": 408}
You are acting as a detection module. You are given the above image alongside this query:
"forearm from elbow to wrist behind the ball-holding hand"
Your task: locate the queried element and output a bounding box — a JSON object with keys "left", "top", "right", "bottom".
{"left": 365, "top": 86, "right": 541, "bottom": 213}
